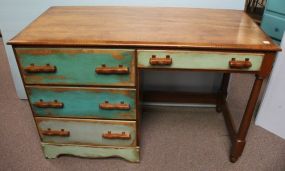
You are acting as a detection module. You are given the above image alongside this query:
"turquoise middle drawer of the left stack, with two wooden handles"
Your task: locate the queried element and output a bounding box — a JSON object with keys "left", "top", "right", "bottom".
{"left": 26, "top": 86, "right": 136, "bottom": 119}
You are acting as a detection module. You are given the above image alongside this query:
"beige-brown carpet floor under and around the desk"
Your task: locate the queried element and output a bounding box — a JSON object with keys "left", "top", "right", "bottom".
{"left": 0, "top": 38, "right": 285, "bottom": 171}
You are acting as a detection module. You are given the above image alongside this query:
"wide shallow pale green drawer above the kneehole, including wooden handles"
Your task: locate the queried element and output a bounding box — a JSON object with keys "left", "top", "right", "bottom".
{"left": 138, "top": 50, "right": 263, "bottom": 71}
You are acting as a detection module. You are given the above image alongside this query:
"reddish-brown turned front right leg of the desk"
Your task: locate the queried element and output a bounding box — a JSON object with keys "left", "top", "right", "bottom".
{"left": 230, "top": 76, "right": 263, "bottom": 162}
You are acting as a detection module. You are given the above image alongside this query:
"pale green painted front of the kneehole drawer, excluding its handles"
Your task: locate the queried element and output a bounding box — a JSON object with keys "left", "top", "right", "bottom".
{"left": 138, "top": 51, "right": 263, "bottom": 71}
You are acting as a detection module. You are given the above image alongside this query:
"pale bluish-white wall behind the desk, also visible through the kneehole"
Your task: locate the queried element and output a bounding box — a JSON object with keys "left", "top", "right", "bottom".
{"left": 0, "top": 0, "right": 245, "bottom": 99}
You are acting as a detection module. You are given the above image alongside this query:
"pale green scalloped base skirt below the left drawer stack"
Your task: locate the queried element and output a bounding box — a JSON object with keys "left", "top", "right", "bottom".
{"left": 42, "top": 143, "right": 139, "bottom": 162}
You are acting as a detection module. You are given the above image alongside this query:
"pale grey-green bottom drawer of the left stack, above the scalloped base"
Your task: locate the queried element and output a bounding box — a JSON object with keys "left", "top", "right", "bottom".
{"left": 35, "top": 117, "right": 136, "bottom": 147}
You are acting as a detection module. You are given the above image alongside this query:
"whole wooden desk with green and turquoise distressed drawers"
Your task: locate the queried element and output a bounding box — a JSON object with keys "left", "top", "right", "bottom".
{"left": 9, "top": 7, "right": 280, "bottom": 162}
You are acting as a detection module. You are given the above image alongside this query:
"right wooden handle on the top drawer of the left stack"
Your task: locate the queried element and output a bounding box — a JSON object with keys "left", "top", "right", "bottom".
{"left": 96, "top": 64, "right": 129, "bottom": 74}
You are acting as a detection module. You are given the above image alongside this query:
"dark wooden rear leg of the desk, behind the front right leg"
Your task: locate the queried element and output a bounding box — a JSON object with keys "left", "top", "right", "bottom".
{"left": 216, "top": 73, "right": 230, "bottom": 113}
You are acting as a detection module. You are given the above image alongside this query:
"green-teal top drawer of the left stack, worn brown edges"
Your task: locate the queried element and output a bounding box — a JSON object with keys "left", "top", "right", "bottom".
{"left": 15, "top": 48, "right": 135, "bottom": 86}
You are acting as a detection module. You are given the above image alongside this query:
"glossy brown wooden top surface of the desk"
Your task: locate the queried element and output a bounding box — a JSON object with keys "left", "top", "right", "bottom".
{"left": 8, "top": 7, "right": 280, "bottom": 51}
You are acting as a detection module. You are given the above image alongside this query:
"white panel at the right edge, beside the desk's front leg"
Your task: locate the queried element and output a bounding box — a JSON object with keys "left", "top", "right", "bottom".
{"left": 255, "top": 33, "right": 285, "bottom": 139}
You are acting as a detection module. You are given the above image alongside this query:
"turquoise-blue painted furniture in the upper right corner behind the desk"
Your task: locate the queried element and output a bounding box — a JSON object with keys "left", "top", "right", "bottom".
{"left": 261, "top": 0, "right": 285, "bottom": 43}
